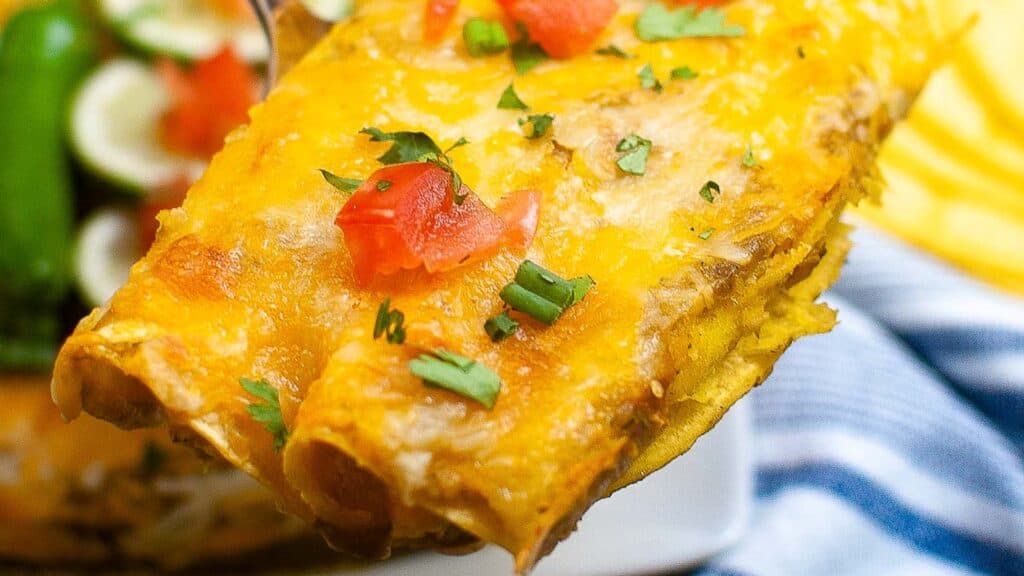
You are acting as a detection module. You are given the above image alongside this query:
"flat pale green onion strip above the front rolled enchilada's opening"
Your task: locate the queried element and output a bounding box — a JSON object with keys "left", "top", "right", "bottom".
{"left": 409, "top": 349, "right": 502, "bottom": 408}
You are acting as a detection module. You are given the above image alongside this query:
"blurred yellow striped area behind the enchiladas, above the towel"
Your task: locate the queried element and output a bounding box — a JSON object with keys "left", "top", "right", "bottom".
{"left": 857, "top": 0, "right": 1024, "bottom": 294}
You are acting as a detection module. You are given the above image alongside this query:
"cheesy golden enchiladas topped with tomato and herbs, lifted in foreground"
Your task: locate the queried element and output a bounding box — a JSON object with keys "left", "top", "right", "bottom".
{"left": 53, "top": 0, "right": 937, "bottom": 570}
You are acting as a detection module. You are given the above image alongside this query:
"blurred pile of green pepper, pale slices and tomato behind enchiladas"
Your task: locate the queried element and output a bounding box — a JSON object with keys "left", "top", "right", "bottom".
{"left": 0, "top": 0, "right": 351, "bottom": 372}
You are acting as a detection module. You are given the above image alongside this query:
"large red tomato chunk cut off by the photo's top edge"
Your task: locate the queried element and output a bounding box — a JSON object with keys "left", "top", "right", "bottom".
{"left": 499, "top": 0, "right": 618, "bottom": 58}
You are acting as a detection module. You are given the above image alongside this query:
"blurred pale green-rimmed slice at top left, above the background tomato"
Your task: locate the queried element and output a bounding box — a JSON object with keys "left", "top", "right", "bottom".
{"left": 99, "top": 0, "right": 269, "bottom": 64}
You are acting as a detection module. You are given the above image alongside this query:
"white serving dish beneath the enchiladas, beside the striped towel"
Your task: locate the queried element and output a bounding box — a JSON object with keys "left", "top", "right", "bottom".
{"left": 311, "top": 402, "right": 754, "bottom": 576}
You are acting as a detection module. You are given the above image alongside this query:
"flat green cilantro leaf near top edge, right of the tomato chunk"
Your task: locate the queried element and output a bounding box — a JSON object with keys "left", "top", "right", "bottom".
{"left": 636, "top": 2, "right": 746, "bottom": 42}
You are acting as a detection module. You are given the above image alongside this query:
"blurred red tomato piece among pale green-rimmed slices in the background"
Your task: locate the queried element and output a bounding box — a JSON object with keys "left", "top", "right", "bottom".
{"left": 157, "top": 47, "right": 259, "bottom": 158}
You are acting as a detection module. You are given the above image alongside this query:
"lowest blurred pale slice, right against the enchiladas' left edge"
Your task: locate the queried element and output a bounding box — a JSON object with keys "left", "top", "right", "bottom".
{"left": 75, "top": 204, "right": 140, "bottom": 306}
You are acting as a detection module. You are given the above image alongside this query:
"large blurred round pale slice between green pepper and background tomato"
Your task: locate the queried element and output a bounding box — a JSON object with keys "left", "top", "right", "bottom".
{"left": 71, "top": 59, "right": 206, "bottom": 194}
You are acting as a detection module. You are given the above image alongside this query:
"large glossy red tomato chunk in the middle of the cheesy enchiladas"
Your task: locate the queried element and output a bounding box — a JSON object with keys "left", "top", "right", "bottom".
{"left": 336, "top": 162, "right": 541, "bottom": 285}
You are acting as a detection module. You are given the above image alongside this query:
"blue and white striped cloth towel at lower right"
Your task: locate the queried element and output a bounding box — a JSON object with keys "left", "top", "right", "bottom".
{"left": 698, "top": 224, "right": 1024, "bottom": 576}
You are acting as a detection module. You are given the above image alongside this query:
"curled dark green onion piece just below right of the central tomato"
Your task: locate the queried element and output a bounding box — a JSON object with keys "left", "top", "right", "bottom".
{"left": 500, "top": 260, "right": 594, "bottom": 325}
